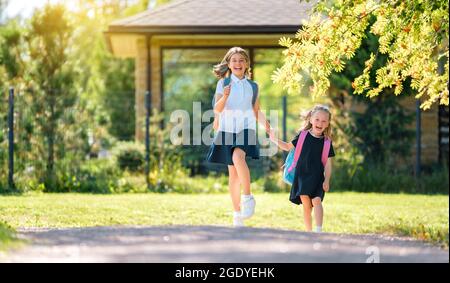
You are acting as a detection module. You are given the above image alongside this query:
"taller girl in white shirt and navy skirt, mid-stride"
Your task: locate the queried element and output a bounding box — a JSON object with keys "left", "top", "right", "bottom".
{"left": 207, "top": 47, "right": 271, "bottom": 229}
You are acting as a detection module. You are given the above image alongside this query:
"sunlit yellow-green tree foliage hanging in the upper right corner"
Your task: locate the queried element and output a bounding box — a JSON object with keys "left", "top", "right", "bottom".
{"left": 272, "top": 0, "right": 449, "bottom": 109}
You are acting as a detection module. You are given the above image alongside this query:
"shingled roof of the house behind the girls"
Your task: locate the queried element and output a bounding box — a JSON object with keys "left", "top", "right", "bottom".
{"left": 108, "top": 0, "right": 315, "bottom": 34}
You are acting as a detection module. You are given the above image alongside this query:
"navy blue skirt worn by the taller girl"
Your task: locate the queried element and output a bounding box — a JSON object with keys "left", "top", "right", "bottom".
{"left": 206, "top": 129, "right": 259, "bottom": 165}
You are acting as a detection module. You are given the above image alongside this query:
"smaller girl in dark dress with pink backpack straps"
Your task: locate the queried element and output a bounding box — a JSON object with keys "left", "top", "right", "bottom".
{"left": 270, "top": 105, "right": 335, "bottom": 232}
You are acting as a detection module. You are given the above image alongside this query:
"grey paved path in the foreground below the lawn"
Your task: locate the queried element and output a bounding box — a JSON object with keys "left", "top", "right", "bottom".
{"left": 0, "top": 226, "right": 449, "bottom": 263}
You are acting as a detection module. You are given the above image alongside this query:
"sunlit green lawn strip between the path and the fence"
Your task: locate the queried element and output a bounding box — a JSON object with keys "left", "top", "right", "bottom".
{"left": 0, "top": 192, "right": 449, "bottom": 247}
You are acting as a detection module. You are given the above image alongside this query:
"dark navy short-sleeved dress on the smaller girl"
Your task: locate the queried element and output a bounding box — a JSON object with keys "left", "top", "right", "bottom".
{"left": 289, "top": 132, "right": 335, "bottom": 204}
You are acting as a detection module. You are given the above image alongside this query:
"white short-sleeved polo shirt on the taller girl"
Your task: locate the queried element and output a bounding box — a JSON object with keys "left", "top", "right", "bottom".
{"left": 216, "top": 74, "right": 256, "bottom": 133}
